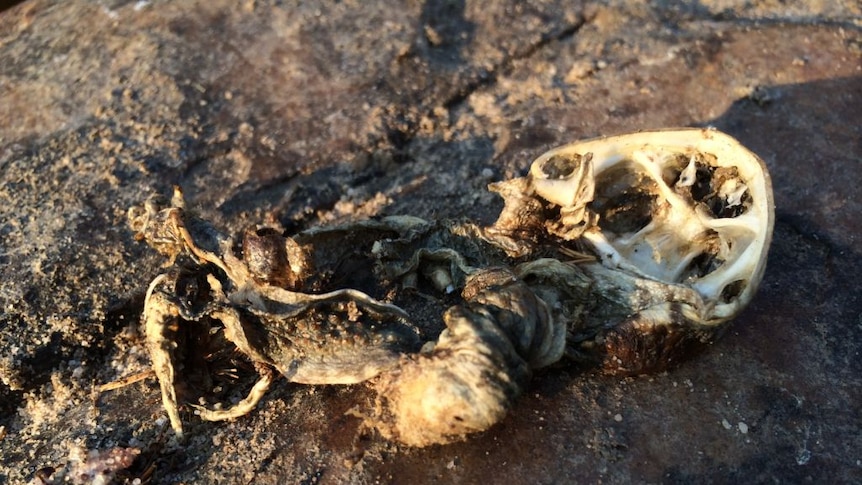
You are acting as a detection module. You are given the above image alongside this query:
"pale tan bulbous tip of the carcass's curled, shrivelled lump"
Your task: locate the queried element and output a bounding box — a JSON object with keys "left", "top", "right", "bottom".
{"left": 370, "top": 307, "right": 530, "bottom": 446}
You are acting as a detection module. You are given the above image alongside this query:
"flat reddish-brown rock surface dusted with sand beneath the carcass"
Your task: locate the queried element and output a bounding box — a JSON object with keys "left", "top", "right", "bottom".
{"left": 0, "top": 0, "right": 862, "bottom": 483}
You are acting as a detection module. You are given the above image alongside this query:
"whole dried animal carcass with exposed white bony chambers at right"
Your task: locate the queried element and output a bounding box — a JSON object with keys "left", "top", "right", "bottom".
{"left": 123, "top": 129, "right": 773, "bottom": 446}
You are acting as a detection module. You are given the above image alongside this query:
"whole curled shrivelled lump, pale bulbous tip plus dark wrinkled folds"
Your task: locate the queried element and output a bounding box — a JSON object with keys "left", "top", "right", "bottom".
{"left": 371, "top": 270, "right": 552, "bottom": 446}
